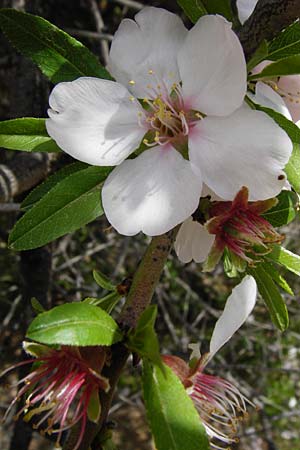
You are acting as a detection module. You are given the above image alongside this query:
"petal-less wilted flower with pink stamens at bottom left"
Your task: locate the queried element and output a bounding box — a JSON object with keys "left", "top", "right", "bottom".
{"left": 2, "top": 343, "right": 110, "bottom": 450}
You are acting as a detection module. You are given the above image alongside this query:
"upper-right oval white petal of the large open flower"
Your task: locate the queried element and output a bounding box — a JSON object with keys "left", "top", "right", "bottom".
{"left": 178, "top": 16, "right": 247, "bottom": 116}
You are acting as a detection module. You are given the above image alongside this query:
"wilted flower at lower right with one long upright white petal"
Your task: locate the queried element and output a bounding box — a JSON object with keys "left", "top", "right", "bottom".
{"left": 163, "top": 276, "right": 257, "bottom": 449}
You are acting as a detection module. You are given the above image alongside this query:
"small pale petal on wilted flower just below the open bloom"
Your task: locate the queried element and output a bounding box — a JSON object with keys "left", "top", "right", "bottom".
{"left": 174, "top": 217, "right": 215, "bottom": 263}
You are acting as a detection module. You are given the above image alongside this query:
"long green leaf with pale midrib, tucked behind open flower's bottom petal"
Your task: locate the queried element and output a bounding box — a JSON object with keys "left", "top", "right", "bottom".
{"left": 9, "top": 166, "right": 112, "bottom": 250}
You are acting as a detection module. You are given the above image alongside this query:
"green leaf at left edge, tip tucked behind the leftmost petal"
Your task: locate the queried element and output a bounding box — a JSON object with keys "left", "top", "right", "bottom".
{"left": 0, "top": 117, "right": 60, "bottom": 152}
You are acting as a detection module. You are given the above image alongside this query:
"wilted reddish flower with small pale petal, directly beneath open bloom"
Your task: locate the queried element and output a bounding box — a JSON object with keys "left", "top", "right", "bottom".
{"left": 175, "top": 187, "right": 283, "bottom": 270}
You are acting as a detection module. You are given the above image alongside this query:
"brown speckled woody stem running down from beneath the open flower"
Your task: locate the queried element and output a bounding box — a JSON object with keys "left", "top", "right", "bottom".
{"left": 63, "top": 227, "right": 179, "bottom": 450}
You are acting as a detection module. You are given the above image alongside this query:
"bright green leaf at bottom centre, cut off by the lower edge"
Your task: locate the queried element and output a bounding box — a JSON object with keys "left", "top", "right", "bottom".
{"left": 143, "top": 362, "right": 210, "bottom": 450}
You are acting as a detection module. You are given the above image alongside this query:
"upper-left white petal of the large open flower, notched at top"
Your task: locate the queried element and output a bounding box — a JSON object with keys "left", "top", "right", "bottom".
{"left": 108, "top": 7, "right": 187, "bottom": 98}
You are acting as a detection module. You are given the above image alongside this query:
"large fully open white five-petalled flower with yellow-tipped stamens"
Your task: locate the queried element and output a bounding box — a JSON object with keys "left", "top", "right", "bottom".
{"left": 46, "top": 7, "right": 291, "bottom": 235}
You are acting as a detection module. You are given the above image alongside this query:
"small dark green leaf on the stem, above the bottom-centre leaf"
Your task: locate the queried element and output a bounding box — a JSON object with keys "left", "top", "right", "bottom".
{"left": 127, "top": 305, "right": 163, "bottom": 370}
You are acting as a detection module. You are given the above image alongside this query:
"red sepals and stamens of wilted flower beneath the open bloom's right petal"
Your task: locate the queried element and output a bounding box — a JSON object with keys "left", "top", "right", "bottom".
{"left": 207, "top": 187, "right": 283, "bottom": 264}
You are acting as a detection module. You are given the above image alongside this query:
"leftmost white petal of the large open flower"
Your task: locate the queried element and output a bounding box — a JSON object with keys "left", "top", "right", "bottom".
{"left": 46, "top": 77, "right": 146, "bottom": 166}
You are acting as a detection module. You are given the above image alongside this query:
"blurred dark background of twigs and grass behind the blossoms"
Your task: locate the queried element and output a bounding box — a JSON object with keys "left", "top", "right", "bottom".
{"left": 0, "top": 0, "right": 300, "bottom": 450}
